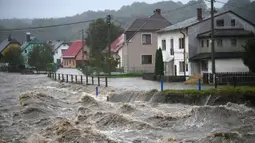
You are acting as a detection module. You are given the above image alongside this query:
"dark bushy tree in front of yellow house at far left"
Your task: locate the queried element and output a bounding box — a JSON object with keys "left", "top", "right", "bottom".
{"left": 2, "top": 46, "right": 23, "bottom": 65}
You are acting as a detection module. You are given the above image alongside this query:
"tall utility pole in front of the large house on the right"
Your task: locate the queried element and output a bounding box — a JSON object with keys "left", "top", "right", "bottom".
{"left": 211, "top": 0, "right": 215, "bottom": 79}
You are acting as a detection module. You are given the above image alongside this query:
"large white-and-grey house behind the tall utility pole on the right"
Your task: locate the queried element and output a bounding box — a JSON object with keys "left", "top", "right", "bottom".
{"left": 158, "top": 8, "right": 255, "bottom": 75}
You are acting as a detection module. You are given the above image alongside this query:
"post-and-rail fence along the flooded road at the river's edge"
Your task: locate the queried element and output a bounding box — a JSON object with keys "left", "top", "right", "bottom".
{"left": 48, "top": 73, "right": 108, "bottom": 87}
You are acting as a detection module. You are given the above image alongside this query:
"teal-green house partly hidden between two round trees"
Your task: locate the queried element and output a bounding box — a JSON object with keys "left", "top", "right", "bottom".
{"left": 21, "top": 32, "right": 43, "bottom": 68}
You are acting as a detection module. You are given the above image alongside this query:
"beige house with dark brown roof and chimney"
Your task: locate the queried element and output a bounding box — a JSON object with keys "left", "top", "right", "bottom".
{"left": 119, "top": 9, "right": 171, "bottom": 72}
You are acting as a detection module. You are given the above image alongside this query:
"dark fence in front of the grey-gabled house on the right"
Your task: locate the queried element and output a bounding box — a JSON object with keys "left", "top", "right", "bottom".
{"left": 203, "top": 72, "right": 255, "bottom": 86}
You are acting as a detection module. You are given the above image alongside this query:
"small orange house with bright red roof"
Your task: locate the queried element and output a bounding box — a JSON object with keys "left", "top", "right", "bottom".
{"left": 62, "top": 40, "right": 89, "bottom": 68}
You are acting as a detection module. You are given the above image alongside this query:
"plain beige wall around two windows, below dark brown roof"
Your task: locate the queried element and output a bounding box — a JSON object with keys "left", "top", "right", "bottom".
{"left": 122, "top": 32, "right": 158, "bottom": 72}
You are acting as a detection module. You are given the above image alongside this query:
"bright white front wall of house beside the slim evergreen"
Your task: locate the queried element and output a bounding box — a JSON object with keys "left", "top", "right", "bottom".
{"left": 158, "top": 30, "right": 190, "bottom": 76}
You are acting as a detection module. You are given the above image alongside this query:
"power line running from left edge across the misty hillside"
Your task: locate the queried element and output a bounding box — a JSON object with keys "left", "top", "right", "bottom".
{"left": 0, "top": 19, "right": 101, "bottom": 32}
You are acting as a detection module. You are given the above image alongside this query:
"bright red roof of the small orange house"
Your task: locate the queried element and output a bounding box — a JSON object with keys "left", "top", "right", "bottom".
{"left": 62, "top": 40, "right": 85, "bottom": 58}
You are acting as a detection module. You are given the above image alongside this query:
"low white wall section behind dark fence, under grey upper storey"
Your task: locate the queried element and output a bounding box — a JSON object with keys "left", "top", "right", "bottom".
{"left": 208, "top": 59, "right": 249, "bottom": 73}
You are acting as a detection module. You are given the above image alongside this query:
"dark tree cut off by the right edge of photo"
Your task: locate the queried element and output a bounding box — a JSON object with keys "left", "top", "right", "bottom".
{"left": 243, "top": 38, "right": 255, "bottom": 73}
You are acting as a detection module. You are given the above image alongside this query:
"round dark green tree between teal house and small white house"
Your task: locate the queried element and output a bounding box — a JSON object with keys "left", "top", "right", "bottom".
{"left": 28, "top": 43, "right": 53, "bottom": 71}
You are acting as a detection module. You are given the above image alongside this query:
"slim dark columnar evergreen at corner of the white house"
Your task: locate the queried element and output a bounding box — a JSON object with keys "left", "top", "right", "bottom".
{"left": 155, "top": 48, "right": 164, "bottom": 75}
